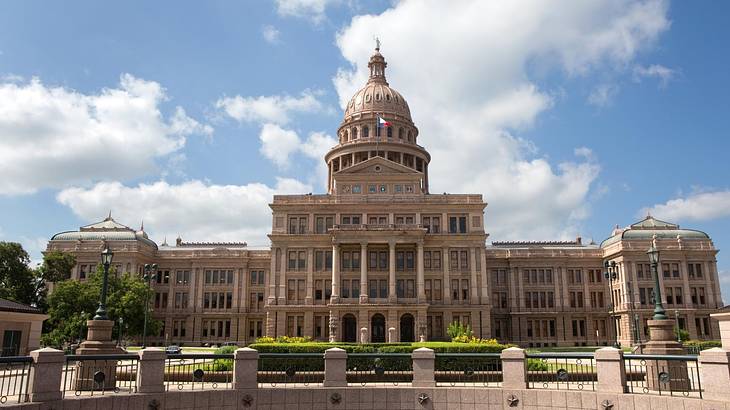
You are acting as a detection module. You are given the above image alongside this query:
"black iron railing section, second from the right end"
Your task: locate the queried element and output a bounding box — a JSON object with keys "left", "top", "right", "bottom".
{"left": 526, "top": 353, "right": 597, "bottom": 390}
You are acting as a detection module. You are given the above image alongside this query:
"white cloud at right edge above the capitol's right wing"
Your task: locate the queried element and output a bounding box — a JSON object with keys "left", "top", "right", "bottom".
{"left": 639, "top": 190, "right": 730, "bottom": 221}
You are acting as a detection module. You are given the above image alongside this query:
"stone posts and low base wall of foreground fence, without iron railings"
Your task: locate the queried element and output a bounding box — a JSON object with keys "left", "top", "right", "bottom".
{"left": 2, "top": 347, "right": 730, "bottom": 410}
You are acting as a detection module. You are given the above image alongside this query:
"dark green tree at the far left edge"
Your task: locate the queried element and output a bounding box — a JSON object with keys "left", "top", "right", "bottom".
{"left": 0, "top": 242, "right": 39, "bottom": 305}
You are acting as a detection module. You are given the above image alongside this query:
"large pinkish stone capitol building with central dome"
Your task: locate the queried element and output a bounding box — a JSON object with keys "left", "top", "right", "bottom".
{"left": 47, "top": 49, "right": 723, "bottom": 347}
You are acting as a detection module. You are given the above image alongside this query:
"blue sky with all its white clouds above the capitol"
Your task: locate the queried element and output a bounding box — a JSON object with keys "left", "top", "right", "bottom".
{"left": 0, "top": 0, "right": 730, "bottom": 295}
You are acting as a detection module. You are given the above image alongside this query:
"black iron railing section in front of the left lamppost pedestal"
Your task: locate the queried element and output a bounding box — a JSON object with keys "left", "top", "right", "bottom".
{"left": 61, "top": 354, "right": 139, "bottom": 397}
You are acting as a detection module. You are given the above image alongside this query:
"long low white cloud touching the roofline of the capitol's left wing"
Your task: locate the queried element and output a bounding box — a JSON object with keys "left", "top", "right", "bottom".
{"left": 57, "top": 178, "right": 312, "bottom": 246}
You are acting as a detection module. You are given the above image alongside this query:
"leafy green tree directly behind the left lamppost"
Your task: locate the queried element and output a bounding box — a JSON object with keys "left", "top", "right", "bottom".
{"left": 41, "top": 265, "right": 161, "bottom": 347}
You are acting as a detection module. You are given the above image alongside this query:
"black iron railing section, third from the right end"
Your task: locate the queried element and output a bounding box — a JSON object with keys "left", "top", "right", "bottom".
{"left": 434, "top": 353, "right": 502, "bottom": 387}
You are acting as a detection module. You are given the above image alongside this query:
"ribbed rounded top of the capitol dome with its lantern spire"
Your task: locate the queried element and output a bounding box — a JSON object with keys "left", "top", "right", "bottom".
{"left": 344, "top": 48, "right": 412, "bottom": 122}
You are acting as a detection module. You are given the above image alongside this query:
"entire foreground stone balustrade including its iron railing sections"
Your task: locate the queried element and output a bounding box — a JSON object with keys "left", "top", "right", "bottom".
{"left": 3, "top": 347, "right": 730, "bottom": 410}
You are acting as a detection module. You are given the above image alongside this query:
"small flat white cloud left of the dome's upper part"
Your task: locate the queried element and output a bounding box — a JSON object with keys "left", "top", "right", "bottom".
{"left": 216, "top": 90, "right": 323, "bottom": 124}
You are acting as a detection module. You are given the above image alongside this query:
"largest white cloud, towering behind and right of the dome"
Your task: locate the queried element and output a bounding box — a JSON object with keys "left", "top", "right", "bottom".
{"left": 333, "top": 0, "right": 669, "bottom": 239}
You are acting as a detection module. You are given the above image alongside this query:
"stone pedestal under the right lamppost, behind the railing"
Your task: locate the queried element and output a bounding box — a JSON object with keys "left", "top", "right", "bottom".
{"left": 644, "top": 319, "right": 691, "bottom": 391}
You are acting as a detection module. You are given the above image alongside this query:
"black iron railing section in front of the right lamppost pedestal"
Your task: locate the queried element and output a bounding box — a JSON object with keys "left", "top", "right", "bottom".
{"left": 624, "top": 354, "right": 702, "bottom": 398}
